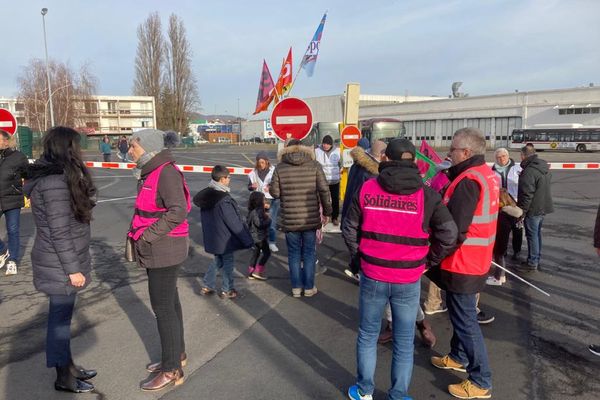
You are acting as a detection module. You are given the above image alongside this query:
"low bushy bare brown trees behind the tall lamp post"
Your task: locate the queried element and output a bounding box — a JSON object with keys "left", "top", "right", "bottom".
{"left": 17, "top": 59, "right": 97, "bottom": 131}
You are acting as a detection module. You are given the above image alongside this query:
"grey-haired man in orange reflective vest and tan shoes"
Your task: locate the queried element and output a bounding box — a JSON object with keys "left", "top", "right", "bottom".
{"left": 429, "top": 128, "right": 500, "bottom": 399}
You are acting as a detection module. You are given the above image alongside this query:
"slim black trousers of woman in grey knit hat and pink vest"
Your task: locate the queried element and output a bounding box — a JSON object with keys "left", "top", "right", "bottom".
{"left": 146, "top": 265, "right": 185, "bottom": 371}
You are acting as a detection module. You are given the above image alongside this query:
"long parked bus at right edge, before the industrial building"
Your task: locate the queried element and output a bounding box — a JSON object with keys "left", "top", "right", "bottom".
{"left": 510, "top": 124, "right": 600, "bottom": 153}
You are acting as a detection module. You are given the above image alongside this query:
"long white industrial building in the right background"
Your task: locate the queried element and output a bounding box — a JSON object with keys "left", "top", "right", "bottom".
{"left": 242, "top": 85, "right": 600, "bottom": 148}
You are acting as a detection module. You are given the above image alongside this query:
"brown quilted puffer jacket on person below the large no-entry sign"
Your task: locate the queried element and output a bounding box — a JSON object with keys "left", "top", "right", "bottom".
{"left": 269, "top": 145, "right": 332, "bottom": 232}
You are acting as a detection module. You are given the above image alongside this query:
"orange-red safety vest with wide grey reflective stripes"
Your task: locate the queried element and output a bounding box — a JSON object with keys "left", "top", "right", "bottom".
{"left": 441, "top": 164, "right": 500, "bottom": 275}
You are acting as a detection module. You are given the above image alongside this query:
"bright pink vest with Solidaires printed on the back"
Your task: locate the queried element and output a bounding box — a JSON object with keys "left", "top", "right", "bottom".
{"left": 359, "top": 178, "right": 429, "bottom": 283}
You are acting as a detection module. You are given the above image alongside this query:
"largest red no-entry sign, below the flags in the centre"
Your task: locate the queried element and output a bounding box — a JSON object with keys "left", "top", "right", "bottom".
{"left": 271, "top": 97, "right": 312, "bottom": 140}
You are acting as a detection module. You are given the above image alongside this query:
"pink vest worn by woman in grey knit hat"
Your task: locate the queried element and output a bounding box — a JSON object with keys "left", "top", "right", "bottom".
{"left": 128, "top": 162, "right": 191, "bottom": 240}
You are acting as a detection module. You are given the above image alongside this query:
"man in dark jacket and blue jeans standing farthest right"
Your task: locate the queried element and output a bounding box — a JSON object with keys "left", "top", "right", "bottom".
{"left": 517, "top": 146, "right": 554, "bottom": 272}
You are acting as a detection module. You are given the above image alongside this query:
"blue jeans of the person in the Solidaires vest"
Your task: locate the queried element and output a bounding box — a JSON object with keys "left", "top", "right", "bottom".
{"left": 356, "top": 274, "right": 421, "bottom": 400}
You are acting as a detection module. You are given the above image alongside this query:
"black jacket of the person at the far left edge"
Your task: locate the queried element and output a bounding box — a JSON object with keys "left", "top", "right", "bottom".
{"left": 0, "top": 149, "right": 27, "bottom": 211}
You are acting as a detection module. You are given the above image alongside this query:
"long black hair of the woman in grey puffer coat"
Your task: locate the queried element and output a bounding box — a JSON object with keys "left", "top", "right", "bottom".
{"left": 41, "top": 126, "right": 96, "bottom": 223}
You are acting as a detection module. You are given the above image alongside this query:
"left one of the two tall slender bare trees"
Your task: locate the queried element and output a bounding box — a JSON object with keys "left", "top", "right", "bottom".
{"left": 133, "top": 12, "right": 165, "bottom": 128}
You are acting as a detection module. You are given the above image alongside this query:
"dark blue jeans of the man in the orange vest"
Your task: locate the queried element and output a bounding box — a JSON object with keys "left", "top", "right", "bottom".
{"left": 446, "top": 291, "right": 492, "bottom": 389}
